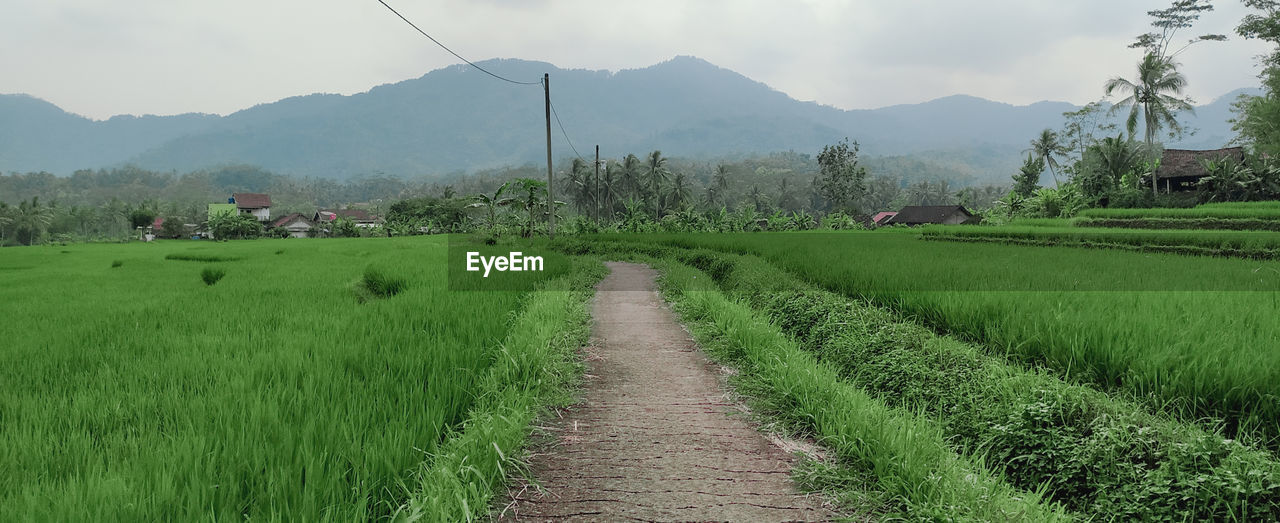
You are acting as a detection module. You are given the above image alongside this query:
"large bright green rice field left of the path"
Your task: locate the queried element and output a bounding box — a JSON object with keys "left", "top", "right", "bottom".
{"left": 0, "top": 237, "right": 562, "bottom": 520}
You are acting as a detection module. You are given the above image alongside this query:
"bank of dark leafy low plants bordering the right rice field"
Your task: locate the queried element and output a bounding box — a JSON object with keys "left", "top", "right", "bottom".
{"left": 660, "top": 246, "right": 1280, "bottom": 520}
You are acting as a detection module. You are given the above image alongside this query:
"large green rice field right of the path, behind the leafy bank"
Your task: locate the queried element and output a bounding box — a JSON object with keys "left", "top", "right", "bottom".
{"left": 586, "top": 233, "right": 1280, "bottom": 449}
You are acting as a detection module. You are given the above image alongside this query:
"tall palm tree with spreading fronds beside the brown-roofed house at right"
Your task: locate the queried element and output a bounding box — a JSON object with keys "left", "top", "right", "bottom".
{"left": 1106, "top": 52, "right": 1193, "bottom": 194}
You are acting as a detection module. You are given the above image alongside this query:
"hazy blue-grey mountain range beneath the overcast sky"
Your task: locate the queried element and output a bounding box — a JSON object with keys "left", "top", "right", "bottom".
{"left": 0, "top": 56, "right": 1254, "bottom": 182}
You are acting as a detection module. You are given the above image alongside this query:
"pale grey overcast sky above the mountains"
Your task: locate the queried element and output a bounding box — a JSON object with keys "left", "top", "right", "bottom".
{"left": 0, "top": 0, "right": 1267, "bottom": 119}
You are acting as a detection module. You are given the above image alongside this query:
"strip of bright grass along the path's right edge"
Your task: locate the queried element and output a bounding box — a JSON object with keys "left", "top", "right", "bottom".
{"left": 657, "top": 262, "right": 1071, "bottom": 520}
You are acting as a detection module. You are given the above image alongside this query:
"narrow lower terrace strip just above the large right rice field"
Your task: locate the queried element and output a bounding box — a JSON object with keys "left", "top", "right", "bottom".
{"left": 920, "top": 225, "right": 1280, "bottom": 260}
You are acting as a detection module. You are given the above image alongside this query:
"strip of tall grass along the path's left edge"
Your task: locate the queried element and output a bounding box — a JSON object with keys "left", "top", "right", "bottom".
{"left": 392, "top": 260, "right": 607, "bottom": 522}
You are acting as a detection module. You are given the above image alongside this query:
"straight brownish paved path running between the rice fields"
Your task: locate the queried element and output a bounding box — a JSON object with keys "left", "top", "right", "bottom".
{"left": 504, "top": 262, "right": 832, "bottom": 522}
